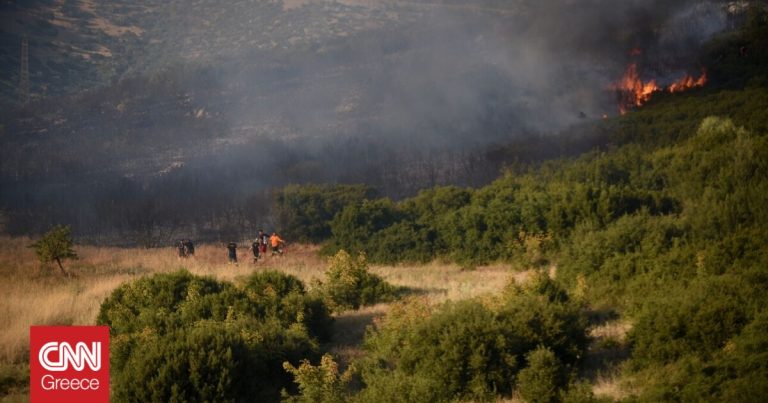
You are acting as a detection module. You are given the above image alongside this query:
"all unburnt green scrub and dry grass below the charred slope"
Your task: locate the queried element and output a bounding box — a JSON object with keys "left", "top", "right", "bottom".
{"left": 0, "top": 6, "right": 768, "bottom": 402}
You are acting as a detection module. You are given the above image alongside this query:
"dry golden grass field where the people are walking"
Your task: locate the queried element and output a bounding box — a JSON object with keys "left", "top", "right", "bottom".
{"left": 0, "top": 237, "right": 526, "bottom": 401}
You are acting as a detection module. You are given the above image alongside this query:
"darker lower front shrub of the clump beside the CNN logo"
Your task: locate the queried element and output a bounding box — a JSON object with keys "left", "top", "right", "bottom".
{"left": 112, "top": 322, "right": 316, "bottom": 402}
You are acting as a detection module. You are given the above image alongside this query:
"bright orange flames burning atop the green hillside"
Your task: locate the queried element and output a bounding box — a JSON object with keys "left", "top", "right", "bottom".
{"left": 612, "top": 63, "right": 707, "bottom": 115}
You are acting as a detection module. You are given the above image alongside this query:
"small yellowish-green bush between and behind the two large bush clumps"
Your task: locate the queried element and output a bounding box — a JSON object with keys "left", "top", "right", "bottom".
{"left": 318, "top": 250, "right": 399, "bottom": 312}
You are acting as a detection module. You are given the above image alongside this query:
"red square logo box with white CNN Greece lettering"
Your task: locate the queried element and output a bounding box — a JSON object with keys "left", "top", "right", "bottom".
{"left": 29, "top": 326, "right": 109, "bottom": 403}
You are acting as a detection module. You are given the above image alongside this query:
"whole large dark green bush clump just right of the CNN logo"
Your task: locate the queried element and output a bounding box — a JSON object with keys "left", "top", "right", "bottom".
{"left": 97, "top": 271, "right": 331, "bottom": 401}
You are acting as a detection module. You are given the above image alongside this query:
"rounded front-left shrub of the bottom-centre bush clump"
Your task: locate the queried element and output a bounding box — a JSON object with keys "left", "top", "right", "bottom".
{"left": 361, "top": 301, "right": 521, "bottom": 401}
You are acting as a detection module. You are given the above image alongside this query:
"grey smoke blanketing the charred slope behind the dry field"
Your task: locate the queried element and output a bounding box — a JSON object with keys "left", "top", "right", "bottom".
{"left": 0, "top": 0, "right": 729, "bottom": 243}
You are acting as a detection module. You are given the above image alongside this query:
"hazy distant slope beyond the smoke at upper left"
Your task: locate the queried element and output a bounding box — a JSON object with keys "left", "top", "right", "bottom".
{"left": 0, "top": 0, "right": 420, "bottom": 101}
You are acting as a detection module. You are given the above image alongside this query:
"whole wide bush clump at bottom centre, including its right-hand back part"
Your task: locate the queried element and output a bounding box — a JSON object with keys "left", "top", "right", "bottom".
{"left": 360, "top": 285, "right": 587, "bottom": 401}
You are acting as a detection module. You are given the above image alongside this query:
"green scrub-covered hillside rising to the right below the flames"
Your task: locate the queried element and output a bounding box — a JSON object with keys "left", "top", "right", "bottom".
{"left": 262, "top": 9, "right": 768, "bottom": 402}
